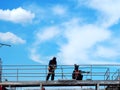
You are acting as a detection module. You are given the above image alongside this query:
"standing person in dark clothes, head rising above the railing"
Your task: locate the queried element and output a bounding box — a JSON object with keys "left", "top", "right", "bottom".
{"left": 46, "top": 57, "right": 57, "bottom": 81}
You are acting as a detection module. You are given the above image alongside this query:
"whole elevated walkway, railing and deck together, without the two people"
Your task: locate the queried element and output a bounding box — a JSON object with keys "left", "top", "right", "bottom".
{"left": 0, "top": 64, "right": 120, "bottom": 90}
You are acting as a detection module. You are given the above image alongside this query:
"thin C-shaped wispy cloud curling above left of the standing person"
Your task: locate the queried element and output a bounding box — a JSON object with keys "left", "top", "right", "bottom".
{"left": 29, "top": 26, "right": 60, "bottom": 64}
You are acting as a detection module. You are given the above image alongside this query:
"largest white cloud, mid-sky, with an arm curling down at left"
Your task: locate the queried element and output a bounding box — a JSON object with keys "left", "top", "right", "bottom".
{"left": 31, "top": 19, "right": 111, "bottom": 64}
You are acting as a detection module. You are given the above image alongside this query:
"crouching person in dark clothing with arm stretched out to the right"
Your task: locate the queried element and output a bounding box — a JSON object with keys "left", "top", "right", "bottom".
{"left": 72, "top": 64, "right": 89, "bottom": 80}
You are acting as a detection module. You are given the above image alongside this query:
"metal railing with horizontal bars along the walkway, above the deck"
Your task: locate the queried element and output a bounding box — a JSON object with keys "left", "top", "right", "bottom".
{"left": 1, "top": 65, "right": 120, "bottom": 81}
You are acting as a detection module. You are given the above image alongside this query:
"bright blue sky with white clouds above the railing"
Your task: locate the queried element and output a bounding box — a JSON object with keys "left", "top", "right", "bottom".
{"left": 0, "top": 0, "right": 120, "bottom": 65}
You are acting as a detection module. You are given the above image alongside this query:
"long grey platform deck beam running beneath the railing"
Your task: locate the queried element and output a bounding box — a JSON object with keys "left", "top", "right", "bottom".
{"left": 0, "top": 80, "right": 120, "bottom": 87}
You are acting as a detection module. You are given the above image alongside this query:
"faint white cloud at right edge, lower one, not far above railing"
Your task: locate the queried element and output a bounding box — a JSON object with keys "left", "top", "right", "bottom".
{"left": 94, "top": 37, "right": 120, "bottom": 60}
